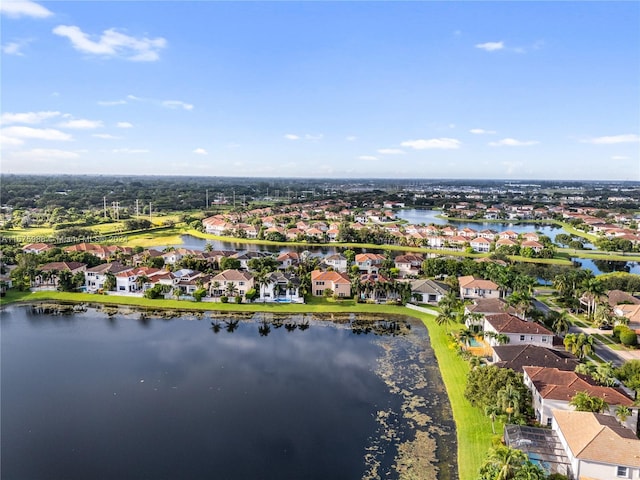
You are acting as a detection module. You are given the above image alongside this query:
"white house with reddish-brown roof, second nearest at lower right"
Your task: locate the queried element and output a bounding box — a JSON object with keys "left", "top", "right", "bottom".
{"left": 523, "top": 366, "right": 638, "bottom": 432}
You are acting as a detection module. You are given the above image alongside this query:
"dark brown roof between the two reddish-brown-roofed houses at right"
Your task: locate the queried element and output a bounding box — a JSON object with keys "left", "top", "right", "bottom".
{"left": 493, "top": 345, "right": 580, "bottom": 372}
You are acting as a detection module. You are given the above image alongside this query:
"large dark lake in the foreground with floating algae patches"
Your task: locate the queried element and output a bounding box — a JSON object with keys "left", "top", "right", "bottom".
{"left": 1, "top": 307, "right": 457, "bottom": 480}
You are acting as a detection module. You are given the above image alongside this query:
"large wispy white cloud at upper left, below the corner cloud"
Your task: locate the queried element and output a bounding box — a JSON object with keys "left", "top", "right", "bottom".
{"left": 53, "top": 25, "right": 167, "bottom": 62}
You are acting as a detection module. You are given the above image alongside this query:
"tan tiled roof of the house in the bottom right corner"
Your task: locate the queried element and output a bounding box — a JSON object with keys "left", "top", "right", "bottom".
{"left": 553, "top": 410, "right": 640, "bottom": 468}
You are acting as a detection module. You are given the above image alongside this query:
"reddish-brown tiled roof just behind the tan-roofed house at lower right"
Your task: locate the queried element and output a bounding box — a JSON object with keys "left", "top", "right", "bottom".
{"left": 523, "top": 367, "right": 633, "bottom": 407}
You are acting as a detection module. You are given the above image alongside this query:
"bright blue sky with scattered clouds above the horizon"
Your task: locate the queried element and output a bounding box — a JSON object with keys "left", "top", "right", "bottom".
{"left": 0, "top": 0, "right": 640, "bottom": 181}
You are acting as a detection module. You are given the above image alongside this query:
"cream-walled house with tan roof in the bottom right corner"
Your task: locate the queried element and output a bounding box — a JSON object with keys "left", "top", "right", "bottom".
{"left": 551, "top": 410, "right": 640, "bottom": 480}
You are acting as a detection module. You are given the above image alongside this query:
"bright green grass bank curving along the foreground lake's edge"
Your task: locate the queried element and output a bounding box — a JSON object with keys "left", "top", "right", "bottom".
{"left": 0, "top": 291, "right": 501, "bottom": 480}
